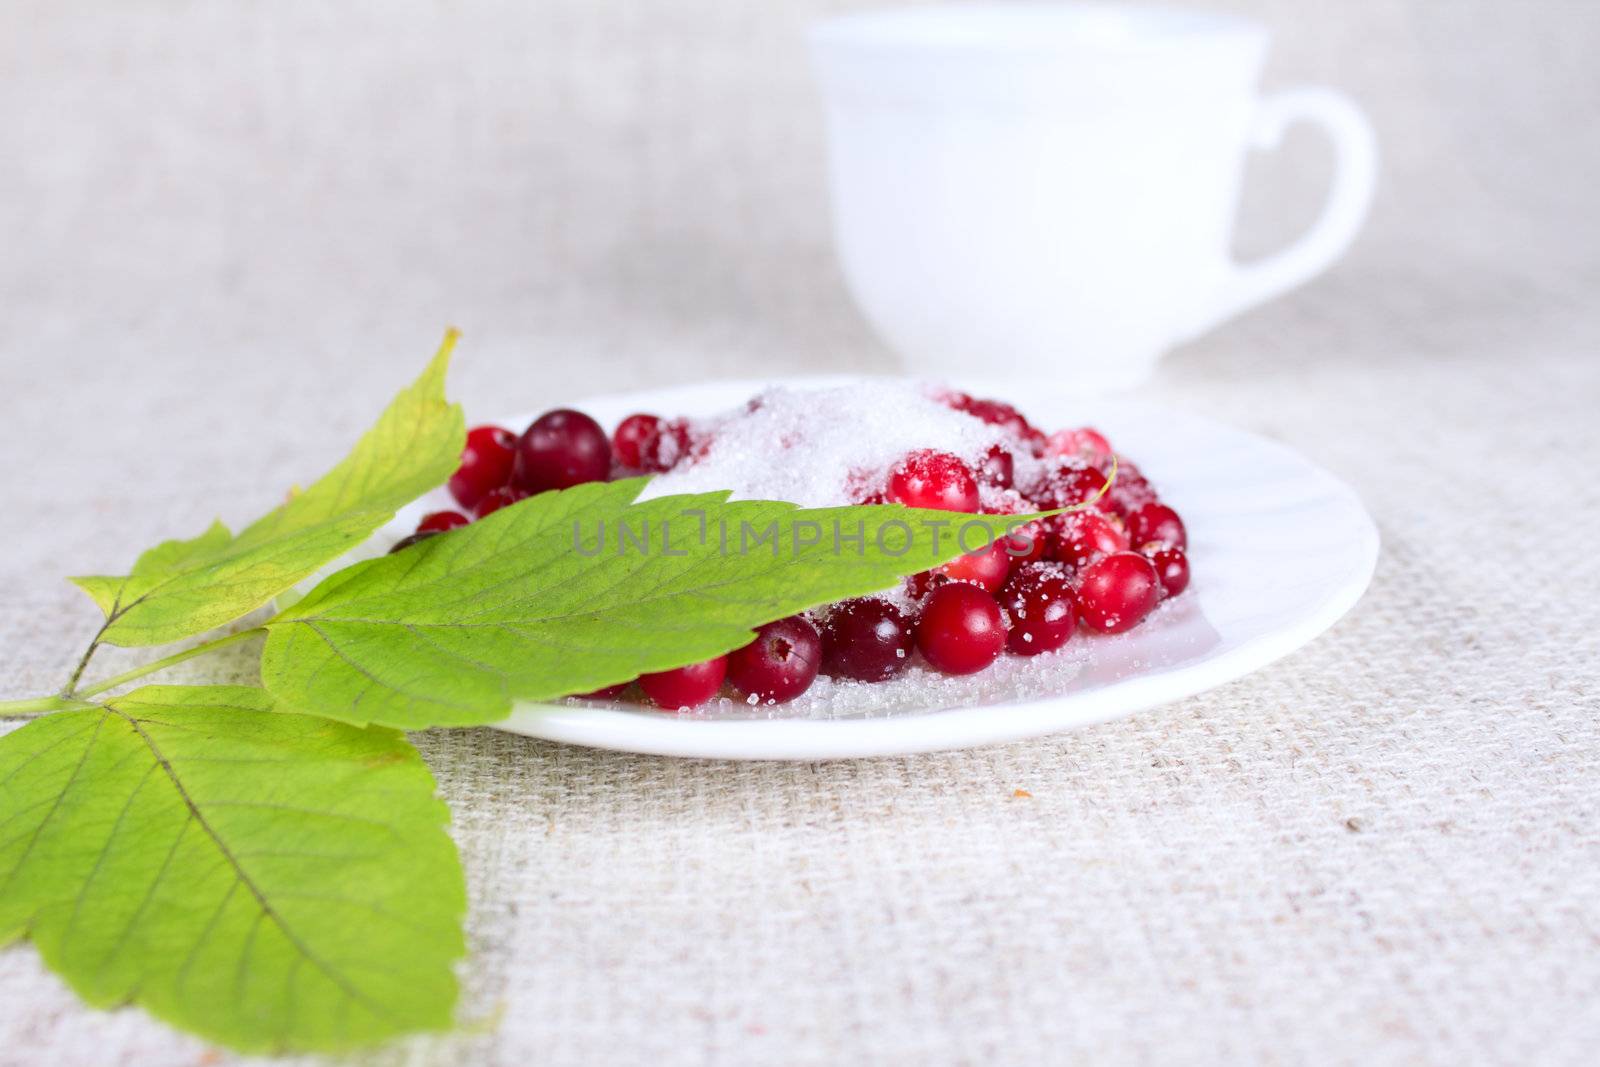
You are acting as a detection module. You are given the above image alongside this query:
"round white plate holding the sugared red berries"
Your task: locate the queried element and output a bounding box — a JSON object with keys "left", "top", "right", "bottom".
{"left": 387, "top": 378, "right": 1378, "bottom": 760}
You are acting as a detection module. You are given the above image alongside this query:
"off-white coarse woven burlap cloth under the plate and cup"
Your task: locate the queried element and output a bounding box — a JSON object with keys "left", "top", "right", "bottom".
{"left": 0, "top": 0, "right": 1600, "bottom": 1067}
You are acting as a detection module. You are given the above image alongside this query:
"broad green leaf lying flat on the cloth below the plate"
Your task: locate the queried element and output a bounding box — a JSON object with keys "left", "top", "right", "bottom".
{"left": 0, "top": 686, "right": 466, "bottom": 1051}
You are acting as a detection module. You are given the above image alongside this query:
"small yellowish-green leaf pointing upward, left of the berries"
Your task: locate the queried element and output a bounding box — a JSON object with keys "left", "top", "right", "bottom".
{"left": 72, "top": 331, "right": 466, "bottom": 645}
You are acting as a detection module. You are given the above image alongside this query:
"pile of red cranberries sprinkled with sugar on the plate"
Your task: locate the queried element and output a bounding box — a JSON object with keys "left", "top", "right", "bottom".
{"left": 392, "top": 394, "right": 1189, "bottom": 710}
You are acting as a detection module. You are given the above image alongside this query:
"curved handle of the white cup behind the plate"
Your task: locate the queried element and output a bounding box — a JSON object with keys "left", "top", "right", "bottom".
{"left": 1187, "top": 88, "right": 1378, "bottom": 336}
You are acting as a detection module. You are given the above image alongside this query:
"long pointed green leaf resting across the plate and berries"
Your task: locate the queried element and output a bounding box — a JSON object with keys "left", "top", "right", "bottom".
{"left": 261, "top": 480, "right": 1026, "bottom": 729}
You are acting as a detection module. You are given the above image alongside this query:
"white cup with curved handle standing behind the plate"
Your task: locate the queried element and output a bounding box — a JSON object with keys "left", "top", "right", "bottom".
{"left": 811, "top": 3, "right": 1378, "bottom": 389}
